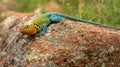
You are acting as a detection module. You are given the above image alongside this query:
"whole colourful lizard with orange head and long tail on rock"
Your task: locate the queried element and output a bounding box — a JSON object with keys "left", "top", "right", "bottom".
{"left": 19, "top": 12, "right": 120, "bottom": 36}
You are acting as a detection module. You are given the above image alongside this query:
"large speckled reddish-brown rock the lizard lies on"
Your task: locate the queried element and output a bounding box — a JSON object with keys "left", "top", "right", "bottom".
{"left": 0, "top": 14, "right": 120, "bottom": 67}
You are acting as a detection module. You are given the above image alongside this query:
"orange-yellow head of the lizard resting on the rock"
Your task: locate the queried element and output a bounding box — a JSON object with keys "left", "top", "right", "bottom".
{"left": 20, "top": 25, "right": 37, "bottom": 35}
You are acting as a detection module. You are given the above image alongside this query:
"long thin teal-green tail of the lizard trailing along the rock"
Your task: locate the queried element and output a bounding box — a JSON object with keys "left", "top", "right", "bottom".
{"left": 50, "top": 12, "right": 120, "bottom": 30}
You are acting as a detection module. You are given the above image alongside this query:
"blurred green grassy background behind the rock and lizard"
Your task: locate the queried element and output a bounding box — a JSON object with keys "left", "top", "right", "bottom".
{"left": 0, "top": 0, "right": 120, "bottom": 28}
